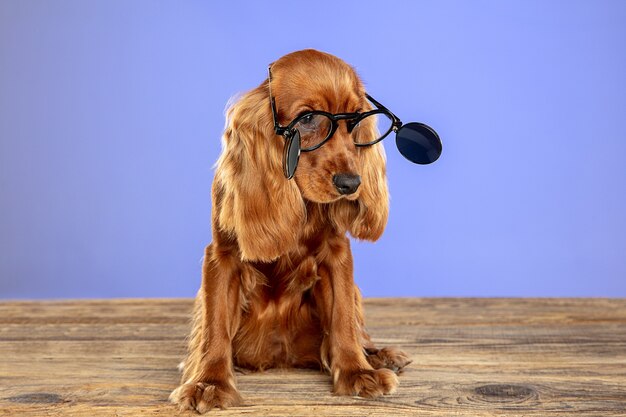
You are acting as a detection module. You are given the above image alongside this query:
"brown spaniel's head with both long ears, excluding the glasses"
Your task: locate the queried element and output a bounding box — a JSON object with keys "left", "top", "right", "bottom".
{"left": 214, "top": 50, "right": 388, "bottom": 261}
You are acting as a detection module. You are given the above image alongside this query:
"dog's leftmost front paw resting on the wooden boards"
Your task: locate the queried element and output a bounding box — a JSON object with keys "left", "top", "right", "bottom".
{"left": 170, "top": 382, "right": 241, "bottom": 414}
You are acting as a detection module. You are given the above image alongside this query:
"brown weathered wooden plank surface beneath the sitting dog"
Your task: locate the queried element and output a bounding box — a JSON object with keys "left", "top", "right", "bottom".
{"left": 0, "top": 299, "right": 626, "bottom": 417}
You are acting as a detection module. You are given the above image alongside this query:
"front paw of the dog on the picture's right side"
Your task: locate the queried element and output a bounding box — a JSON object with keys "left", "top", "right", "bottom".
{"left": 333, "top": 369, "right": 398, "bottom": 398}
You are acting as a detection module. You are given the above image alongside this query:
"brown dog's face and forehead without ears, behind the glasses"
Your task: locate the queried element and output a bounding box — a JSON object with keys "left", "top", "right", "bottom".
{"left": 272, "top": 50, "right": 375, "bottom": 203}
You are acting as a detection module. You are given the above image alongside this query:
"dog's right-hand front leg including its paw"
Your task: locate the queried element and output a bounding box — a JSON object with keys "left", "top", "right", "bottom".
{"left": 315, "top": 236, "right": 398, "bottom": 397}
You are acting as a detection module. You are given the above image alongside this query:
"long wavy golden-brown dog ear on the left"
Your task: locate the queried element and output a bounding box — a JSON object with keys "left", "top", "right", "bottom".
{"left": 213, "top": 81, "right": 306, "bottom": 261}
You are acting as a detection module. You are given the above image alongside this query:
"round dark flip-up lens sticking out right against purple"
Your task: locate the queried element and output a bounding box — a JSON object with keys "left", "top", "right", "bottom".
{"left": 396, "top": 122, "right": 442, "bottom": 165}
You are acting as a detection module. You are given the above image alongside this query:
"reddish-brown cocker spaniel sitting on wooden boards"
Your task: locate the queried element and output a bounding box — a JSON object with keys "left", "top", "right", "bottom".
{"left": 170, "top": 49, "right": 410, "bottom": 413}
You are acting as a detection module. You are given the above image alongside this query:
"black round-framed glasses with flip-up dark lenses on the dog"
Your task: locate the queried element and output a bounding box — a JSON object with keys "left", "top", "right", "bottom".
{"left": 268, "top": 67, "right": 442, "bottom": 179}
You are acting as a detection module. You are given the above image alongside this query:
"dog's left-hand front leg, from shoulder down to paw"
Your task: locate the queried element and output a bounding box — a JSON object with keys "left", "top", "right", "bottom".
{"left": 170, "top": 244, "right": 241, "bottom": 413}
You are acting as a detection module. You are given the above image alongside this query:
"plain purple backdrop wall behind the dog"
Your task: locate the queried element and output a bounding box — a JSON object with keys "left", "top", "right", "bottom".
{"left": 0, "top": 0, "right": 626, "bottom": 298}
